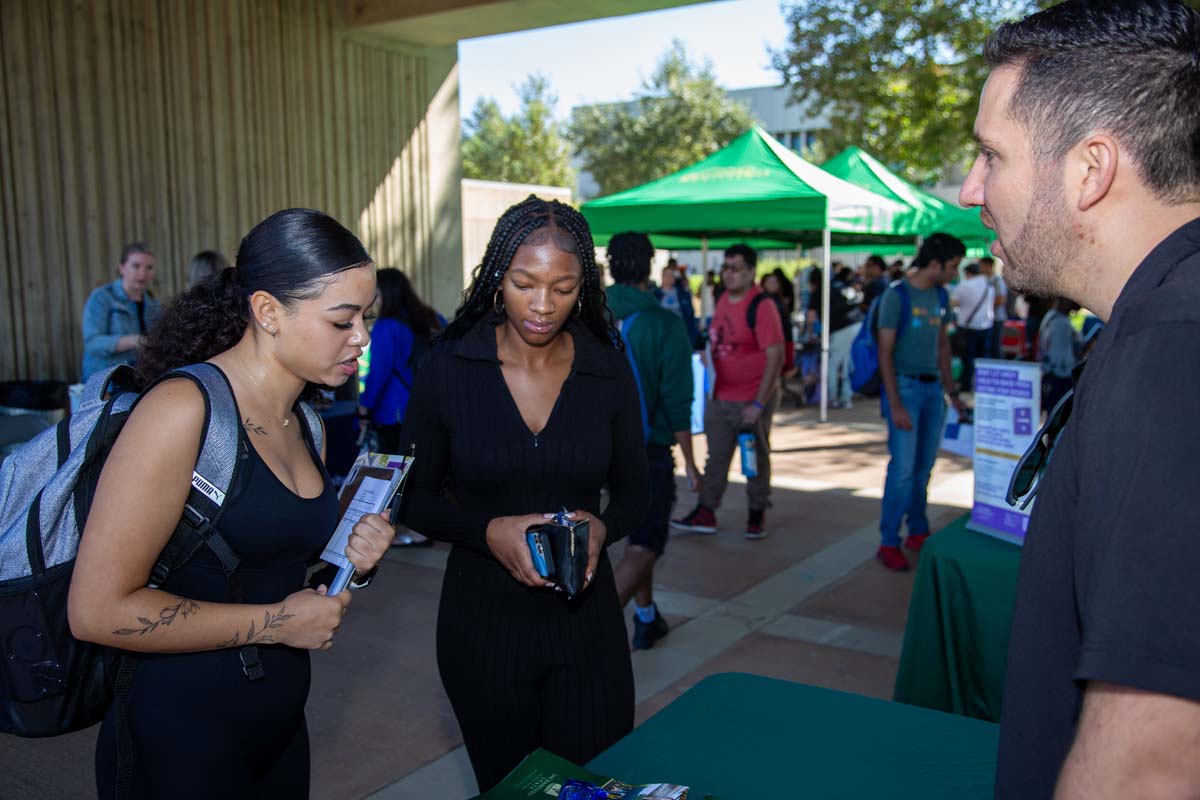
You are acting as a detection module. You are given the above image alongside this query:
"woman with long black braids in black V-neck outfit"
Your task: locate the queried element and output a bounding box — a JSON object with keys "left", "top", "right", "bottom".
{"left": 401, "top": 197, "right": 649, "bottom": 792}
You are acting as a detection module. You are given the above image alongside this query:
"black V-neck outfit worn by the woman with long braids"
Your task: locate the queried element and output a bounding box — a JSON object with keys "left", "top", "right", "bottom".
{"left": 402, "top": 320, "right": 649, "bottom": 792}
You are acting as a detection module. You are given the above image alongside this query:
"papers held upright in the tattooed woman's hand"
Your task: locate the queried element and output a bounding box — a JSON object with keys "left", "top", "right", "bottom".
{"left": 320, "top": 452, "right": 414, "bottom": 595}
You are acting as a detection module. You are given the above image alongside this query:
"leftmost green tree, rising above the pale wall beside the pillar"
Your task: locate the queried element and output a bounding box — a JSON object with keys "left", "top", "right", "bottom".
{"left": 462, "top": 74, "right": 575, "bottom": 187}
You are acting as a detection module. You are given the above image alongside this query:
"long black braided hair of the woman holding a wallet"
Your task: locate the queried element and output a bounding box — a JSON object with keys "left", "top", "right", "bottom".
{"left": 439, "top": 194, "right": 622, "bottom": 349}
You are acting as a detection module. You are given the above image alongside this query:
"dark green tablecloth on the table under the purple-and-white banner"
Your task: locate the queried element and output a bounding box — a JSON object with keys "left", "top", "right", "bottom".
{"left": 894, "top": 515, "right": 1021, "bottom": 722}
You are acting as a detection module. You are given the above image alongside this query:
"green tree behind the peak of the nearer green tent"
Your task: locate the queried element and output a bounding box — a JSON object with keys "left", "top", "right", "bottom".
{"left": 569, "top": 40, "right": 754, "bottom": 194}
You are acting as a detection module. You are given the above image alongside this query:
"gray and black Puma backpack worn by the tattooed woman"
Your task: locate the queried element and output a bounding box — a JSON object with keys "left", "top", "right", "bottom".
{"left": 0, "top": 363, "right": 323, "bottom": 736}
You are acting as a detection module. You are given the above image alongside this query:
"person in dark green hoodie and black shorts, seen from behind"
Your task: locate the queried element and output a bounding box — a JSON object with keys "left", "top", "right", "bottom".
{"left": 607, "top": 233, "right": 700, "bottom": 650}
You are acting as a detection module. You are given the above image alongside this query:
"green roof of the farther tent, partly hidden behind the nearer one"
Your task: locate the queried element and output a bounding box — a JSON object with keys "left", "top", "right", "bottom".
{"left": 821, "top": 148, "right": 996, "bottom": 247}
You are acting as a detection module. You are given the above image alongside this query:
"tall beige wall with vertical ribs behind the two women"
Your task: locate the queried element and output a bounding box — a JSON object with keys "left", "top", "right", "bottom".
{"left": 0, "top": 0, "right": 433, "bottom": 380}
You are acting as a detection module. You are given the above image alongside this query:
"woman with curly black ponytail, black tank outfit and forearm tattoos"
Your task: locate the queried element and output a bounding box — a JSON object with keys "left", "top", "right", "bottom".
{"left": 68, "top": 209, "right": 392, "bottom": 799}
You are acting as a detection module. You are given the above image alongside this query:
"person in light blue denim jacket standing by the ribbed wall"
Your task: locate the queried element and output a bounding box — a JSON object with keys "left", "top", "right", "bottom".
{"left": 83, "top": 242, "right": 162, "bottom": 380}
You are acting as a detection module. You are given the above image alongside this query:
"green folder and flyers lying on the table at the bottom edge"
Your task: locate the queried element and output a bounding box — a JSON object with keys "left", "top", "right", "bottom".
{"left": 475, "top": 750, "right": 716, "bottom": 800}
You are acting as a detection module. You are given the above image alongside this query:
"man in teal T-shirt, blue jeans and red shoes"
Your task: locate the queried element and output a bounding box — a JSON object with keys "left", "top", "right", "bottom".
{"left": 868, "top": 234, "right": 966, "bottom": 572}
